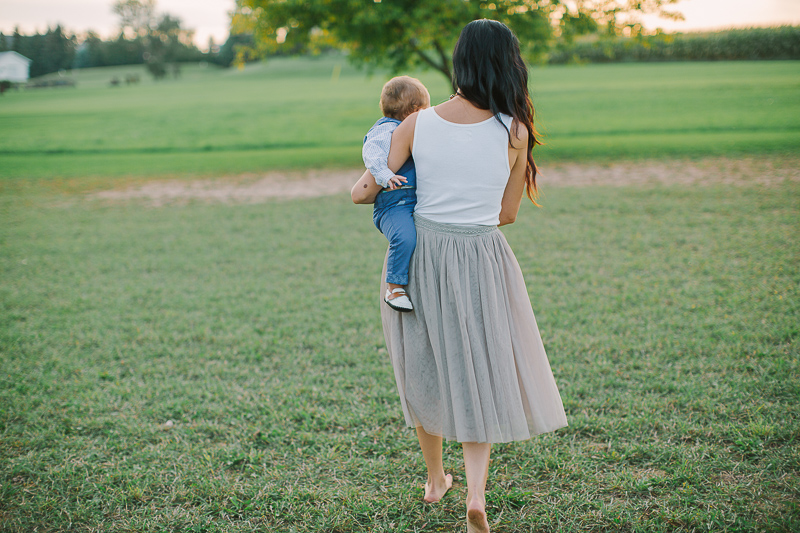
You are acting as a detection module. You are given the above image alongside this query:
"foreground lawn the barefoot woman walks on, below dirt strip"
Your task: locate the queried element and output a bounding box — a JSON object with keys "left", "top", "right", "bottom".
{"left": 0, "top": 180, "right": 800, "bottom": 533}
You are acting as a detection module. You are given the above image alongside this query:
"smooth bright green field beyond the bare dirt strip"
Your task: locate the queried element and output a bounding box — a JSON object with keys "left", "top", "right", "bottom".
{"left": 0, "top": 55, "right": 800, "bottom": 178}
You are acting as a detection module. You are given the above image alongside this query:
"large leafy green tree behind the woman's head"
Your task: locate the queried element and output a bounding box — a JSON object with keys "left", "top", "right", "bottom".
{"left": 231, "top": 0, "right": 679, "bottom": 88}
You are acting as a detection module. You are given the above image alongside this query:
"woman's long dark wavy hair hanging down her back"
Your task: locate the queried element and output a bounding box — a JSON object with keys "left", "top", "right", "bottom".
{"left": 453, "top": 19, "right": 541, "bottom": 203}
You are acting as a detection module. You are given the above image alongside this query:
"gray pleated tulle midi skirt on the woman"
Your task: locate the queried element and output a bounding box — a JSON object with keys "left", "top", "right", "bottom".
{"left": 381, "top": 215, "right": 567, "bottom": 443}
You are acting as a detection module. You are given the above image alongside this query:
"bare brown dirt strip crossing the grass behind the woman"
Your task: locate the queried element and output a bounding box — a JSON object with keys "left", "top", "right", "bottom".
{"left": 90, "top": 157, "right": 800, "bottom": 206}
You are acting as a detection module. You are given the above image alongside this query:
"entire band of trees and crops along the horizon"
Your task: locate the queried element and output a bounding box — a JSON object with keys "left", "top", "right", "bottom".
{"left": 0, "top": 0, "right": 800, "bottom": 83}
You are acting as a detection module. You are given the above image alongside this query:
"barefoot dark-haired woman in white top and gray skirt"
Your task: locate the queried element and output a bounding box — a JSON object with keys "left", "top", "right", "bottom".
{"left": 352, "top": 20, "right": 567, "bottom": 532}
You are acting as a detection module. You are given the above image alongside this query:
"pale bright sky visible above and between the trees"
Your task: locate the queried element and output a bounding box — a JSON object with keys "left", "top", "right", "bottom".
{"left": 0, "top": 0, "right": 800, "bottom": 50}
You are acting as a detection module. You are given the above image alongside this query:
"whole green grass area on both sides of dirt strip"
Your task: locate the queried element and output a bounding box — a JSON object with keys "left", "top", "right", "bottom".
{"left": 0, "top": 57, "right": 800, "bottom": 533}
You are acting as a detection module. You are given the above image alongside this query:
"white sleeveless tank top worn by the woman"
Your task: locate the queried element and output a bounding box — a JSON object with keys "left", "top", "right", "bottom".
{"left": 411, "top": 107, "right": 512, "bottom": 226}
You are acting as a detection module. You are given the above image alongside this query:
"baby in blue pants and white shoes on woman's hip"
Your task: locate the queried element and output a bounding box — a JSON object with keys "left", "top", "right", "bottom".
{"left": 362, "top": 76, "right": 431, "bottom": 312}
